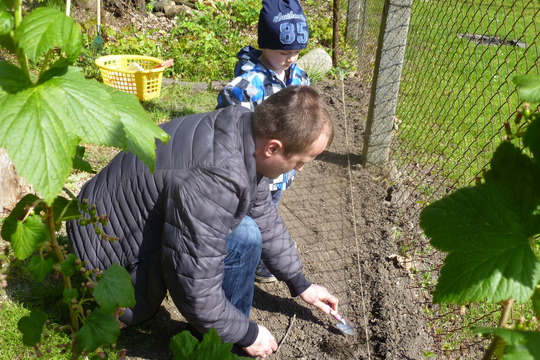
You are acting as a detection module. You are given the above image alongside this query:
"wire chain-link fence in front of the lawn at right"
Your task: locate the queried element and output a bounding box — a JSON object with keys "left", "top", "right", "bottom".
{"left": 345, "top": 0, "right": 540, "bottom": 358}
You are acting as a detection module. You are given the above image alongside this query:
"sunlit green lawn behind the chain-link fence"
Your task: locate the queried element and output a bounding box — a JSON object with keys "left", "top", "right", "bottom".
{"left": 396, "top": 0, "right": 539, "bottom": 185}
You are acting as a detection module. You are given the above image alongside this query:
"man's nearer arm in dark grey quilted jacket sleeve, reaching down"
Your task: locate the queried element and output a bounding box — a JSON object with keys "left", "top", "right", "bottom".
{"left": 162, "top": 169, "right": 258, "bottom": 346}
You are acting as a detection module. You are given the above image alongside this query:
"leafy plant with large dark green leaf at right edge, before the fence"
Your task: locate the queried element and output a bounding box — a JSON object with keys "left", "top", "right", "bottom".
{"left": 420, "top": 75, "right": 540, "bottom": 360}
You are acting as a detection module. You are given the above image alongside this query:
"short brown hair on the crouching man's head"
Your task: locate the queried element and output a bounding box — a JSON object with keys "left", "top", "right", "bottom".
{"left": 253, "top": 85, "right": 334, "bottom": 157}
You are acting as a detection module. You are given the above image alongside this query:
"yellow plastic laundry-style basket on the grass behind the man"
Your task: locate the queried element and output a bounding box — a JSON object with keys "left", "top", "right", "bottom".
{"left": 95, "top": 55, "right": 165, "bottom": 101}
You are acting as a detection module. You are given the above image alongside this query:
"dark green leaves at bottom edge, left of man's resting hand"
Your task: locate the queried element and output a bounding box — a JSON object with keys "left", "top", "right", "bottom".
{"left": 170, "top": 328, "right": 249, "bottom": 360}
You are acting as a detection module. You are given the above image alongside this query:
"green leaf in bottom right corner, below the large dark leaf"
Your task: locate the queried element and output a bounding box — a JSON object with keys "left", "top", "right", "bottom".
{"left": 473, "top": 327, "right": 540, "bottom": 360}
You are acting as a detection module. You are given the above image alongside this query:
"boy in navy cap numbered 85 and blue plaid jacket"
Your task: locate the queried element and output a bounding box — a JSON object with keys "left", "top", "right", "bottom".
{"left": 217, "top": 0, "right": 310, "bottom": 282}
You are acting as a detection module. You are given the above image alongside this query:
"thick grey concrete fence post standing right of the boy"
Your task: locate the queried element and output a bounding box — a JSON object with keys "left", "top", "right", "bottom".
{"left": 362, "top": 0, "right": 412, "bottom": 171}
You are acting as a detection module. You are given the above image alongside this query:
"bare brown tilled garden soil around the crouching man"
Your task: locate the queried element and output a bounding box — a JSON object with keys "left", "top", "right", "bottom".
{"left": 118, "top": 79, "right": 433, "bottom": 360}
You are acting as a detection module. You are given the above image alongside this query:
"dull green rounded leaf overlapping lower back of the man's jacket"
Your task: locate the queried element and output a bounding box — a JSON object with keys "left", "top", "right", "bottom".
{"left": 94, "top": 264, "right": 135, "bottom": 313}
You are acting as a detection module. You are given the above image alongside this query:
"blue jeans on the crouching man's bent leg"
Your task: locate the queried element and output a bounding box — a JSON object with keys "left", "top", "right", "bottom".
{"left": 222, "top": 216, "right": 262, "bottom": 317}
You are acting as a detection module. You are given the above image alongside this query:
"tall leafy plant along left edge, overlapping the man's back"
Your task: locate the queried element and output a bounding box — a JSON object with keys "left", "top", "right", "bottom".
{"left": 0, "top": 0, "right": 168, "bottom": 358}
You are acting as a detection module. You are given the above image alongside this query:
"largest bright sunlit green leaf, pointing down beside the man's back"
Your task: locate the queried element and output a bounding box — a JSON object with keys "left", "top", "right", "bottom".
{"left": 0, "top": 68, "right": 168, "bottom": 203}
